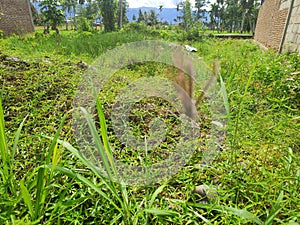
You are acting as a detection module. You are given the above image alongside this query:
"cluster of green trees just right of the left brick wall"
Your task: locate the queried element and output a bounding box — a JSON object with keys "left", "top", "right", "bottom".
{"left": 31, "top": 0, "right": 128, "bottom": 32}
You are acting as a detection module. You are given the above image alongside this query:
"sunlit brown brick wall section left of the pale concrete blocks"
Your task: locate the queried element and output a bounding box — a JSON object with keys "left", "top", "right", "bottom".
{"left": 254, "top": 0, "right": 290, "bottom": 50}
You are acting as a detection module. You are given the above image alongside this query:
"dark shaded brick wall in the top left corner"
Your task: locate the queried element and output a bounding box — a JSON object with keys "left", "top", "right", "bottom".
{"left": 0, "top": 0, "right": 34, "bottom": 35}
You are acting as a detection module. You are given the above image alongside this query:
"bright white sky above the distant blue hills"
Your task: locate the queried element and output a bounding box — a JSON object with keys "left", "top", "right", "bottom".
{"left": 127, "top": 0, "right": 216, "bottom": 8}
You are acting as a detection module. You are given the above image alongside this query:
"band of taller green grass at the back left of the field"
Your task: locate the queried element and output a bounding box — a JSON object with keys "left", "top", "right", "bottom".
{"left": 0, "top": 31, "right": 154, "bottom": 62}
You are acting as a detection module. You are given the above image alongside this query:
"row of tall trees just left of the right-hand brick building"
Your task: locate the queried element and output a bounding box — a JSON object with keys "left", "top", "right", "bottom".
{"left": 177, "top": 0, "right": 261, "bottom": 32}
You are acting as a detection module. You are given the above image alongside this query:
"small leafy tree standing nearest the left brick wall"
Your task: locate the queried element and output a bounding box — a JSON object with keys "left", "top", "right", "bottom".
{"left": 40, "top": 0, "right": 64, "bottom": 33}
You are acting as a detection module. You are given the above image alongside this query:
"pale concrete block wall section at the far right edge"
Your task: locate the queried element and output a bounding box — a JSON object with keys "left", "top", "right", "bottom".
{"left": 282, "top": 0, "right": 300, "bottom": 53}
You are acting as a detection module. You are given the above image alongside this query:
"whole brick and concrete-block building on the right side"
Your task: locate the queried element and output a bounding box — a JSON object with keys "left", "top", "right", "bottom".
{"left": 254, "top": 0, "right": 300, "bottom": 53}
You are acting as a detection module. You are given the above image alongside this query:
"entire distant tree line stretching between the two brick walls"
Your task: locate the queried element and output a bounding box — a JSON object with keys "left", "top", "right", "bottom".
{"left": 31, "top": 0, "right": 260, "bottom": 32}
